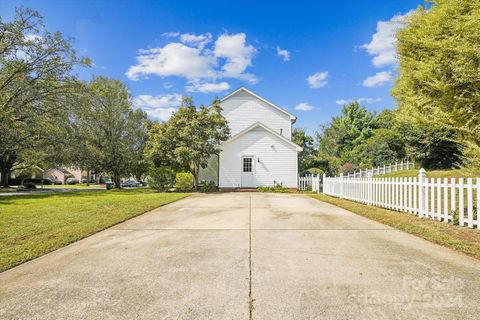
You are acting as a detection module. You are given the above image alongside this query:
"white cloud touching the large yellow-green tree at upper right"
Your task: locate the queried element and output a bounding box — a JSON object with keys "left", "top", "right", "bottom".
{"left": 361, "top": 10, "right": 414, "bottom": 68}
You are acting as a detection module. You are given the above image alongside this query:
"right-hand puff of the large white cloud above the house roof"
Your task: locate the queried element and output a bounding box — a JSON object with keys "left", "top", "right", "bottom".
{"left": 214, "top": 33, "right": 257, "bottom": 83}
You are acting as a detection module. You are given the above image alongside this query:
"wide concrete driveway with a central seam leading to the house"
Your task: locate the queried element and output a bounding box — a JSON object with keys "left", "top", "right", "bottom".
{"left": 0, "top": 193, "right": 480, "bottom": 320}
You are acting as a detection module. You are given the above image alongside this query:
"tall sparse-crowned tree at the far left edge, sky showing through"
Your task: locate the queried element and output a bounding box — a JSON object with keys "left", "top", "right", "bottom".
{"left": 0, "top": 7, "right": 90, "bottom": 186}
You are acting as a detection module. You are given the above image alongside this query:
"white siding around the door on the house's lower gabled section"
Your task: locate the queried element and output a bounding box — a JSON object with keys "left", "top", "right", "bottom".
{"left": 219, "top": 127, "right": 297, "bottom": 188}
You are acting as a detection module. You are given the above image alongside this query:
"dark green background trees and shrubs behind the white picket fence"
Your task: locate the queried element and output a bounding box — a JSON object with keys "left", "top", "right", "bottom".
{"left": 312, "top": 104, "right": 461, "bottom": 175}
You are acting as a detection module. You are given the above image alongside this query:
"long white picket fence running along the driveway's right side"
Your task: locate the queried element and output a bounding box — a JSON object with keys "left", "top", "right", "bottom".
{"left": 323, "top": 168, "right": 480, "bottom": 229}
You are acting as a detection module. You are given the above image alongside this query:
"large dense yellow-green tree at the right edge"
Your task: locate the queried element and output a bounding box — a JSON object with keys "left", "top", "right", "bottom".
{"left": 392, "top": 0, "right": 480, "bottom": 168}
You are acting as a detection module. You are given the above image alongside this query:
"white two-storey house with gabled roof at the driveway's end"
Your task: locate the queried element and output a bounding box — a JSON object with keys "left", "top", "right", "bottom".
{"left": 199, "top": 88, "right": 302, "bottom": 189}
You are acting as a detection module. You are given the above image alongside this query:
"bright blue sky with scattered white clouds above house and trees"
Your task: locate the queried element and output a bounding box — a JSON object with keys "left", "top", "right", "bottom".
{"left": 0, "top": 0, "right": 423, "bottom": 133}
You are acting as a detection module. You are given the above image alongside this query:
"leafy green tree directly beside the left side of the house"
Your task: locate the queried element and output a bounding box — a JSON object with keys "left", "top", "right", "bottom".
{"left": 146, "top": 97, "right": 230, "bottom": 189}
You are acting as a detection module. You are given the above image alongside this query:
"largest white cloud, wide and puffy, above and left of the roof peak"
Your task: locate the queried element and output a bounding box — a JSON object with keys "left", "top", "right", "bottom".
{"left": 125, "top": 32, "right": 257, "bottom": 87}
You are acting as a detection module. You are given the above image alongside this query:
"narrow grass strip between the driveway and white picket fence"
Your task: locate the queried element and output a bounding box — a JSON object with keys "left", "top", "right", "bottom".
{"left": 309, "top": 194, "right": 480, "bottom": 259}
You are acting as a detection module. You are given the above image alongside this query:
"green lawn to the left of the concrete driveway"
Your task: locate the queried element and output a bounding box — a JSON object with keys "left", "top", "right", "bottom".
{"left": 0, "top": 189, "right": 188, "bottom": 272}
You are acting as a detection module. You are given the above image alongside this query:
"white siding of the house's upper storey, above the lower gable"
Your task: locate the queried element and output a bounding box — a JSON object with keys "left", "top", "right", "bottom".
{"left": 221, "top": 91, "right": 292, "bottom": 140}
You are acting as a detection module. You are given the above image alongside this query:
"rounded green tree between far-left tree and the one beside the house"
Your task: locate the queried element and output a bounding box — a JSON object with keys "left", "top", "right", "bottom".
{"left": 77, "top": 77, "right": 146, "bottom": 188}
